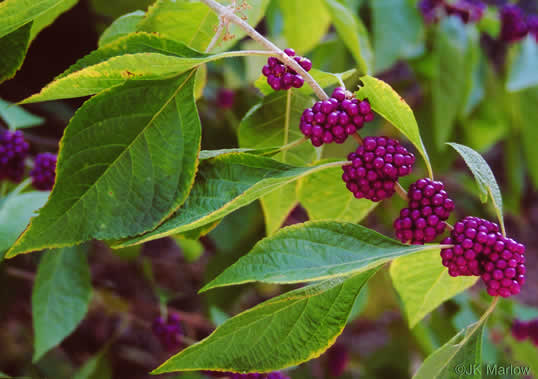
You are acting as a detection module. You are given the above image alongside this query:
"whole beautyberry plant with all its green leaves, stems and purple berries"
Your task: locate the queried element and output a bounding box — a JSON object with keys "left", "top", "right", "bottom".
{"left": 0, "top": 0, "right": 538, "bottom": 379}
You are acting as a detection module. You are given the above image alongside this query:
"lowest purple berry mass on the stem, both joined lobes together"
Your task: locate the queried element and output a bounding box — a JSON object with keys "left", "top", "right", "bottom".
{"left": 441, "top": 216, "right": 526, "bottom": 297}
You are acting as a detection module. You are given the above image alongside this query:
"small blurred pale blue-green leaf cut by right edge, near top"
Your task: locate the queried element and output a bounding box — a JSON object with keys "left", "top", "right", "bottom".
{"left": 506, "top": 34, "right": 538, "bottom": 92}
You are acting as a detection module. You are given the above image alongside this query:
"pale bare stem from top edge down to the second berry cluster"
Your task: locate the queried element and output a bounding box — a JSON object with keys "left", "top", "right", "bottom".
{"left": 201, "top": 0, "right": 329, "bottom": 100}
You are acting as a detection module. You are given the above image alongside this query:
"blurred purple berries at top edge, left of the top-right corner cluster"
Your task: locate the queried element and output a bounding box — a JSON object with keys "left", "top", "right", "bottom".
{"left": 418, "top": 0, "right": 486, "bottom": 24}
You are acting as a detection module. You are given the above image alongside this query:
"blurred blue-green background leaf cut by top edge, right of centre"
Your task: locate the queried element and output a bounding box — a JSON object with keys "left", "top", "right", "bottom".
{"left": 370, "top": 0, "right": 424, "bottom": 72}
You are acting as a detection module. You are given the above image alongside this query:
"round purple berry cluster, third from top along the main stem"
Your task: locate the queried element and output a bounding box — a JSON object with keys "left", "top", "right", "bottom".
{"left": 342, "top": 137, "right": 415, "bottom": 201}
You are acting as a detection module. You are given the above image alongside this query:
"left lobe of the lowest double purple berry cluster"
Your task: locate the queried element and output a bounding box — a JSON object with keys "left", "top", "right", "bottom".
{"left": 441, "top": 216, "right": 502, "bottom": 276}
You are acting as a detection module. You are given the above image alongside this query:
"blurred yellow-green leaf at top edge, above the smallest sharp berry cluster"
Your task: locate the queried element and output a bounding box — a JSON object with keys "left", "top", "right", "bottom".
{"left": 279, "top": 0, "right": 331, "bottom": 54}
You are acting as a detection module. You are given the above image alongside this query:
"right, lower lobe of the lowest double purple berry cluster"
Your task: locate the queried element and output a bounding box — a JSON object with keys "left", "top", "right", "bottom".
{"left": 479, "top": 233, "right": 527, "bottom": 297}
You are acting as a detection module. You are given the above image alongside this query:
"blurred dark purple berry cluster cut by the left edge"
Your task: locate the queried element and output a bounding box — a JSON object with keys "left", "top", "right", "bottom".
{"left": 0, "top": 130, "right": 30, "bottom": 182}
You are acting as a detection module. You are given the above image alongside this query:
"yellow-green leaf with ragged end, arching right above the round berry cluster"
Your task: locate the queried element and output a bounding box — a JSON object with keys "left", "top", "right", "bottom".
{"left": 356, "top": 76, "right": 433, "bottom": 180}
